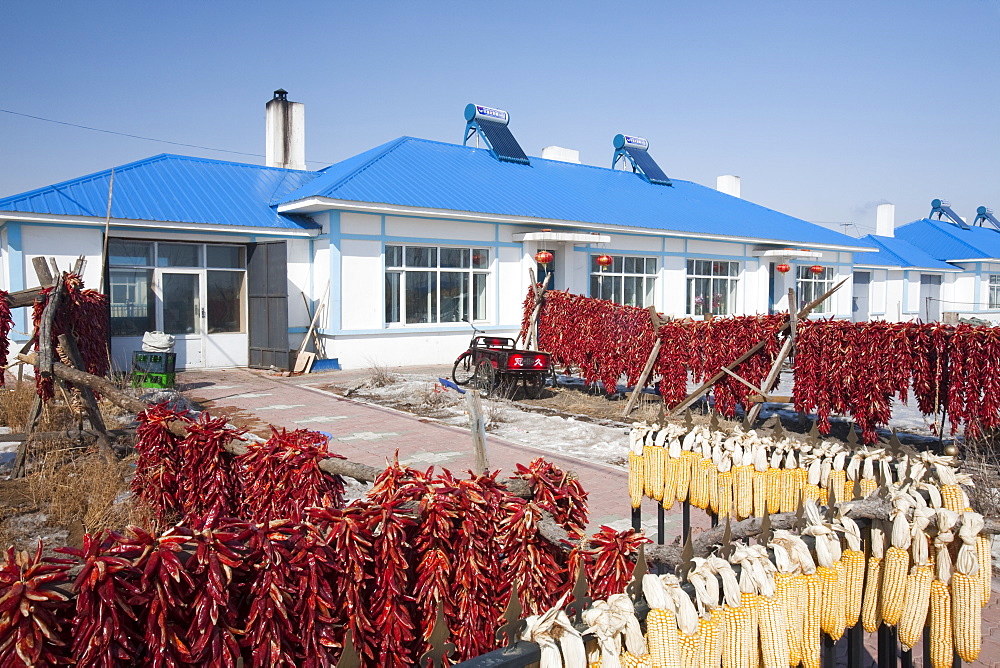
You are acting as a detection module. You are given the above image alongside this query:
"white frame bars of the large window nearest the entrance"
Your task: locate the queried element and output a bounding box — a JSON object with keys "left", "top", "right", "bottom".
{"left": 382, "top": 242, "right": 496, "bottom": 329}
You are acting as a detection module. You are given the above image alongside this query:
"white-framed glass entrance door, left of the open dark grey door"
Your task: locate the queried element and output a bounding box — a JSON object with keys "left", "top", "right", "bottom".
{"left": 159, "top": 269, "right": 205, "bottom": 369}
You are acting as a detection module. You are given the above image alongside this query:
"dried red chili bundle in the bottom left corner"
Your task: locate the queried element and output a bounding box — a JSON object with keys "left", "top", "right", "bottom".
{"left": 0, "top": 541, "right": 73, "bottom": 666}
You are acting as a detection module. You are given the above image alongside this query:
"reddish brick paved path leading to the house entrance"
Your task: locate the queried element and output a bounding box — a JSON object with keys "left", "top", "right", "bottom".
{"left": 178, "top": 367, "right": 1000, "bottom": 668}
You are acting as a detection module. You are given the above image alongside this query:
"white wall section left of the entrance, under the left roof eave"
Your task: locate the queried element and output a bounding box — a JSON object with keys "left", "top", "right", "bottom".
{"left": 22, "top": 225, "right": 104, "bottom": 290}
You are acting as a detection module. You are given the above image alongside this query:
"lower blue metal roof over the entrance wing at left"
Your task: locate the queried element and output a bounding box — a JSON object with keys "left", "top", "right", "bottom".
{"left": 0, "top": 154, "right": 317, "bottom": 230}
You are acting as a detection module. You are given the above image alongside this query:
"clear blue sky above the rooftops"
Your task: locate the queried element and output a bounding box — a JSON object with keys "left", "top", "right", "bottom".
{"left": 0, "top": 0, "right": 1000, "bottom": 234}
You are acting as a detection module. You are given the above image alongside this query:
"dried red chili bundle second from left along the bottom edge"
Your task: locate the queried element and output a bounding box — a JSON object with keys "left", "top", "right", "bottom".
{"left": 56, "top": 533, "right": 148, "bottom": 668}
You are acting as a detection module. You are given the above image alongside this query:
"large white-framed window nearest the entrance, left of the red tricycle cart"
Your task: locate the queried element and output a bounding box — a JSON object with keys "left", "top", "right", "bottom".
{"left": 385, "top": 246, "right": 490, "bottom": 325}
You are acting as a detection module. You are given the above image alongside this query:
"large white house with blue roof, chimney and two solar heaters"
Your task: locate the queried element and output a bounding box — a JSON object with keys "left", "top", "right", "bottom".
{"left": 0, "top": 91, "right": 884, "bottom": 368}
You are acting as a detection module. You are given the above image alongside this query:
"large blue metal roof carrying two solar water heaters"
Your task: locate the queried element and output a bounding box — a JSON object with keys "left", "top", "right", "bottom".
{"left": 278, "top": 137, "right": 868, "bottom": 248}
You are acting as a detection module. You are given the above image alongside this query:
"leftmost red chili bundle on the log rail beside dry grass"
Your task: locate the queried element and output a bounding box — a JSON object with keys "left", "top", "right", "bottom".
{"left": 130, "top": 404, "right": 190, "bottom": 526}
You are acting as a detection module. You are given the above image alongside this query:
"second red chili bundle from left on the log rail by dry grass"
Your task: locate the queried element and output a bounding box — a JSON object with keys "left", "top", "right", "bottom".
{"left": 177, "top": 411, "right": 245, "bottom": 524}
